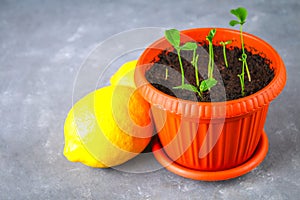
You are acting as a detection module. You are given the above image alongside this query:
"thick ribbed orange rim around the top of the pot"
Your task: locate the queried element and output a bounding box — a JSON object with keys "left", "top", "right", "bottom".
{"left": 134, "top": 28, "right": 286, "bottom": 119}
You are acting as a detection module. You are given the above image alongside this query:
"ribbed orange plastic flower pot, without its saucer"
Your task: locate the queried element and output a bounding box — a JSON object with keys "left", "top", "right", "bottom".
{"left": 135, "top": 28, "right": 286, "bottom": 171}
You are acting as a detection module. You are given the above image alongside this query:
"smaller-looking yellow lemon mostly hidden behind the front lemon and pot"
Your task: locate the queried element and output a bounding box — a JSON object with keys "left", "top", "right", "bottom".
{"left": 110, "top": 60, "right": 137, "bottom": 87}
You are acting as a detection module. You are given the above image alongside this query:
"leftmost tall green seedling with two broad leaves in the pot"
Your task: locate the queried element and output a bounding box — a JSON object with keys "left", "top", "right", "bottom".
{"left": 165, "top": 29, "right": 197, "bottom": 86}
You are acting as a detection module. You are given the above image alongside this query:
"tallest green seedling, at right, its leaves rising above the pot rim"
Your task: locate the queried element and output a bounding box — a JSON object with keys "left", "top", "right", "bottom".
{"left": 229, "top": 7, "right": 251, "bottom": 96}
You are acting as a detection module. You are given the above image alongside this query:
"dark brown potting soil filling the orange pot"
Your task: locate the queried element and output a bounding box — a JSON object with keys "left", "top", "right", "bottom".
{"left": 146, "top": 42, "right": 274, "bottom": 102}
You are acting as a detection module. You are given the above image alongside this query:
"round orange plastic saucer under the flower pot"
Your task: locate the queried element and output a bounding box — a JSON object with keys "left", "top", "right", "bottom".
{"left": 152, "top": 131, "right": 269, "bottom": 181}
